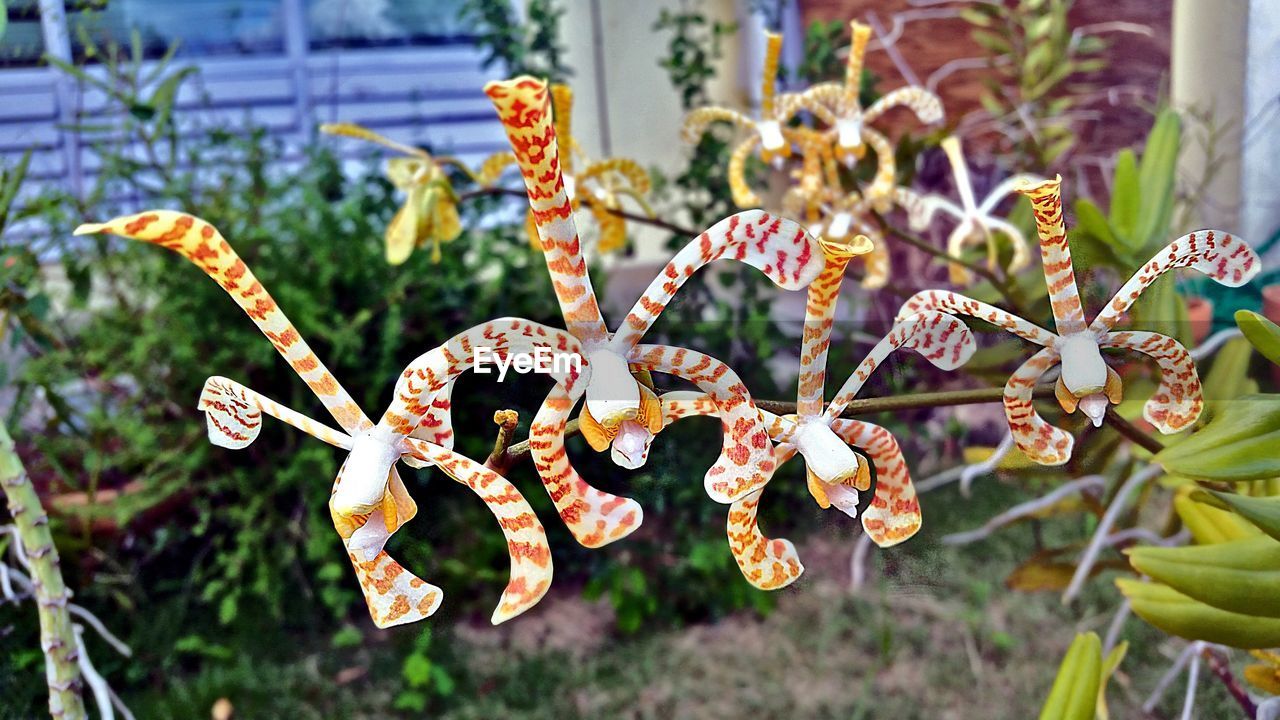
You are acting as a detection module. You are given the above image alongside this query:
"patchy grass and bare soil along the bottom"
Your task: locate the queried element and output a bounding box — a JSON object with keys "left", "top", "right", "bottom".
{"left": 104, "top": 480, "right": 1239, "bottom": 720}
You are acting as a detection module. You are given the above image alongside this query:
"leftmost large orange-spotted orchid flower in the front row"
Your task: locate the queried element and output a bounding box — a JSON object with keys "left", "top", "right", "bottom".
{"left": 76, "top": 210, "right": 565, "bottom": 628}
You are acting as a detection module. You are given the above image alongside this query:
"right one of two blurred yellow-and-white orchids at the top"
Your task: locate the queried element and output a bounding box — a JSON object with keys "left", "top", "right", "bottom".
{"left": 796, "top": 20, "right": 942, "bottom": 204}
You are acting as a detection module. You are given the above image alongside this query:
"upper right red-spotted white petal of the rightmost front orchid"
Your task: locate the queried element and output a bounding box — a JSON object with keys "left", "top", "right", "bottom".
{"left": 1089, "top": 231, "right": 1262, "bottom": 333}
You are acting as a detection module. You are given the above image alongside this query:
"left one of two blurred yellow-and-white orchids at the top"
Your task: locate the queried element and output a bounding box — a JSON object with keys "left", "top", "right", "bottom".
{"left": 681, "top": 32, "right": 800, "bottom": 208}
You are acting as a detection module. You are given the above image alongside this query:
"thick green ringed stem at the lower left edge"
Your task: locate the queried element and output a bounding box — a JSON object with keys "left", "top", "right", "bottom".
{"left": 0, "top": 423, "right": 86, "bottom": 720}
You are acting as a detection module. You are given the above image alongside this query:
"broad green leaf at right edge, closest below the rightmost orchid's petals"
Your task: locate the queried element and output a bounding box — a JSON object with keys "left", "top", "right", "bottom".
{"left": 1156, "top": 395, "right": 1280, "bottom": 482}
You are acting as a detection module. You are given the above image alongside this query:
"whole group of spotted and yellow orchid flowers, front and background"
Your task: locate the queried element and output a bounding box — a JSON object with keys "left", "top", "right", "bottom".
{"left": 77, "top": 23, "right": 1258, "bottom": 626}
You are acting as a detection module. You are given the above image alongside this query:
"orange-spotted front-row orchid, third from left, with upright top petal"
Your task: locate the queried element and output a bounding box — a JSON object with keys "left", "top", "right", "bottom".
{"left": 662, "top": 236, "right": 975, "bottom": 589}
